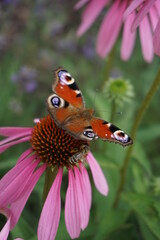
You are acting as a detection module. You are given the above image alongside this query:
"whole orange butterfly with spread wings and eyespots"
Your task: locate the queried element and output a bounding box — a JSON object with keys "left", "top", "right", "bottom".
{"left": 47, "top": 68, "right": 132, "bottom": 146}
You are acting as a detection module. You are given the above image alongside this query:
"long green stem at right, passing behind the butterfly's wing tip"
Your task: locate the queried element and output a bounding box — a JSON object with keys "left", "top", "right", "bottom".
{"left": 113, "top": 69, "right": 160, "bottom": 208}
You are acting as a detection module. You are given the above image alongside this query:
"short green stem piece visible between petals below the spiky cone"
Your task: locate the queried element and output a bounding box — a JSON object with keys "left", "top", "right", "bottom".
{"left": 42, "top": 167, "right": 58, "bottom": 204}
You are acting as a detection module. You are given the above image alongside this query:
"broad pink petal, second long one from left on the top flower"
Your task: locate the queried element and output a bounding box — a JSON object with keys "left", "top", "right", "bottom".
{"left": 96, "top": 1, "right": 127, "bottom": 57}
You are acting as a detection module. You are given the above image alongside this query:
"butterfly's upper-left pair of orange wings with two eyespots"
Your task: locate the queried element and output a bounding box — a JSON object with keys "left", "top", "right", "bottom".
{"left": 47, "top": 68, "right": 85, "bottom": 129}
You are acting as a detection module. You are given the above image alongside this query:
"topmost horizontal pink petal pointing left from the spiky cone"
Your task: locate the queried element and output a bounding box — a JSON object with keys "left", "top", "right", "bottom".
{"left": 0, "top": 127, "right": 33, "bottom": 137}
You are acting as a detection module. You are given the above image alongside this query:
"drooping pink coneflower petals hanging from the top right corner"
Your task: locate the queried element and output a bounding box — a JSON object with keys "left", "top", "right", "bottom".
{"left": 75, "top": 0, "right": 160, "bottom": 62}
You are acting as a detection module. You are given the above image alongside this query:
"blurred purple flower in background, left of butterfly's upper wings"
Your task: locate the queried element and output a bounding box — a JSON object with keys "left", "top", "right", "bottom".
{"left": 11, "top": 66, "right": 37, "bottom": 93}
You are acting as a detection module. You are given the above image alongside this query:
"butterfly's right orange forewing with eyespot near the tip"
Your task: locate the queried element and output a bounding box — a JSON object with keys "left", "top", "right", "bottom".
{"left": 91, "top": 117, "right": 133, "bottom": 146}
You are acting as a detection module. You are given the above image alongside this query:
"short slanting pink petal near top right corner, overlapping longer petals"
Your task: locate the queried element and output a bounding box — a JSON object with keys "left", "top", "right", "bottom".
{"left": 132, "top": 0, "right": 155, "bottom": 31}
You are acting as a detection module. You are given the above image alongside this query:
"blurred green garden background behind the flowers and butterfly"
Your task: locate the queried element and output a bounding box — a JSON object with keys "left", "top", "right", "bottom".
{"left": 0, "top": 0, "right": 160, "bottom": 240}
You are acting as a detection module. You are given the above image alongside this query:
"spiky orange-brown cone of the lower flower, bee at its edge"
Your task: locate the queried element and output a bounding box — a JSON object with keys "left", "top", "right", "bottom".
{"left": 30, "top": 115, "right": 89, "bottom": 168}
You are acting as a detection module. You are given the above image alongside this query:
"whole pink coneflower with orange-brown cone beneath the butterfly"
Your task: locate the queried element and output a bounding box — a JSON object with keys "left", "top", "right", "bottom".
{"left": 0, "top": 116, "right": 108, "bottom": 240}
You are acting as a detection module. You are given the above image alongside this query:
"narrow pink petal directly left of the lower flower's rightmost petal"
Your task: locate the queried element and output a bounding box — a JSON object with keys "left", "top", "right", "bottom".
{"left": 80, "top": 163, "right": 92, "bottom": 208}
